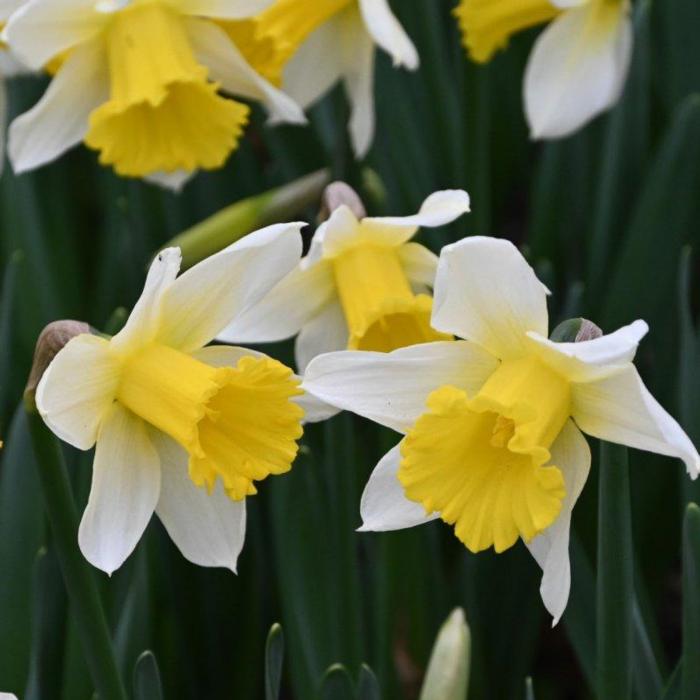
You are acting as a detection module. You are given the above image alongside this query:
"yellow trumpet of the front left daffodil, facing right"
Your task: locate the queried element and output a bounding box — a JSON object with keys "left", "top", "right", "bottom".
{"left": 117, "top": 345, "right": 303, "bottom": 500}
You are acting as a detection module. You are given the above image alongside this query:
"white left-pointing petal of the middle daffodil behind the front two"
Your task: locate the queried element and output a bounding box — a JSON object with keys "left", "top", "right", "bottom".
{"left": 219, "top": 261, "right": 335, "bottom": 343}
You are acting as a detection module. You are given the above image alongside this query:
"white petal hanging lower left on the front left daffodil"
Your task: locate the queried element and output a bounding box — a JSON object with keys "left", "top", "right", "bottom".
{"left": 78, "top": 403, "right": 160, "bottom": 574}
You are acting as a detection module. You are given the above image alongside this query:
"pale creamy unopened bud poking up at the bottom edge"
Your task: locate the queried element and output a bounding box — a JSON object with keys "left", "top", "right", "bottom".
{"left": 420, "top": 608, "right": 471, "bottom": 700}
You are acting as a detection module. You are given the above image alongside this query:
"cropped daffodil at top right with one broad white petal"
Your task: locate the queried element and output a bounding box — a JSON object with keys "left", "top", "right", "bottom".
{"left": 455, "top": 0, "right": 632, "bottom": 139}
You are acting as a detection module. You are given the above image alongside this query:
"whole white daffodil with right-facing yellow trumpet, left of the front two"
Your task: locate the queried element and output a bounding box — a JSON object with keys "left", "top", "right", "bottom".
{"left": 36, "top": 224, "right": 303, "bottom": 573}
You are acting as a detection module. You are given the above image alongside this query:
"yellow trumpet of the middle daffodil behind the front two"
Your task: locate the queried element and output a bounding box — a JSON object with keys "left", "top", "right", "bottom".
{"left": 333, "top": 243, "right": 451, "bottom": 352}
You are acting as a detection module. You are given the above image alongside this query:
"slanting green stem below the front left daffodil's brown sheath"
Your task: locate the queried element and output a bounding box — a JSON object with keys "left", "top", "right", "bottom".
{"left": 27, "top": 405, "right": 127, "bottom": 700}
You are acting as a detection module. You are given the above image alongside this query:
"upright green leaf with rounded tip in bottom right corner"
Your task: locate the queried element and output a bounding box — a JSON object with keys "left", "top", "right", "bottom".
{"left": 681, "top": 503, "right": 700, "bottom": 700}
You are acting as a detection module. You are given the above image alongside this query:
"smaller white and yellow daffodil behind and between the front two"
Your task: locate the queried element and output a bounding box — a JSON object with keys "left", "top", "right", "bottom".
{"left": 219, "top": 190, "right": 469, "bottom": 372}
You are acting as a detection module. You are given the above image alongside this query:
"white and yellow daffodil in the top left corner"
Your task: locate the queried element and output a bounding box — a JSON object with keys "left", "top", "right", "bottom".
{"left": 4, "top": 0, "right": 305, "bottom": 186}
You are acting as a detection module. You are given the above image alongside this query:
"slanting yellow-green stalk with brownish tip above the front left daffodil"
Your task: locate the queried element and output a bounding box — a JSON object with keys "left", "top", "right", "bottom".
{"left": 164, "top": 170, "right": 330, "bottom": 268}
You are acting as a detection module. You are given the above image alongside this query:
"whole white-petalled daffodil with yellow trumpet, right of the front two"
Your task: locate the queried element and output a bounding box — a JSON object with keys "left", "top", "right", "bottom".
{"left": 303, "top": 237, "right": 700, "bottom": 622}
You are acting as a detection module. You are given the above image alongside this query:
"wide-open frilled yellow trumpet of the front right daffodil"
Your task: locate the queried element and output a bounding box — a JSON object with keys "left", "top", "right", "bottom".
{"left": 399, "top": 357, "right": 571, "bottom": 552}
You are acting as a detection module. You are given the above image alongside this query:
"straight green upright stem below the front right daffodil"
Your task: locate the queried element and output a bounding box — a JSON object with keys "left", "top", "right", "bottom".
{"left": 596, "top": 442, "right": 634, "bottom": 700}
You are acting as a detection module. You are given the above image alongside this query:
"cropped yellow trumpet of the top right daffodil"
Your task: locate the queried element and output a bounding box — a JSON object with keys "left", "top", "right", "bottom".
{"left": 455, "top": 0, "right": 561, "bottom": 63}
